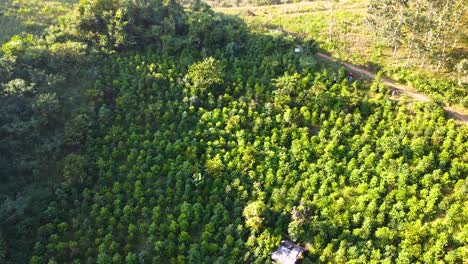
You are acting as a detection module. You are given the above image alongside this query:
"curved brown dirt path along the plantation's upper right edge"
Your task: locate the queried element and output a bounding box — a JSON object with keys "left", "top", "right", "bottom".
{"left": 316, "top": 52, "right": 468, "bottom": 125}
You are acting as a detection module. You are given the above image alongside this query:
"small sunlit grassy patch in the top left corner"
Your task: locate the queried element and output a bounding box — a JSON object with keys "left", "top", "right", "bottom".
{"left": 0, "top": 0, "right": 78, "bottom": 44}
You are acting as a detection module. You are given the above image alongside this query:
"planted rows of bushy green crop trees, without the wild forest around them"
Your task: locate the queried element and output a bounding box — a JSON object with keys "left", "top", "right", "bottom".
{"left": 32, "top": 18, "right": 467, "bottom": 263}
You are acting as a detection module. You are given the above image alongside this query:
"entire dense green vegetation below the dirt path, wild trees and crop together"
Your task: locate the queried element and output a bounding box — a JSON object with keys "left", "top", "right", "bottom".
{"left": 0, "top": 0, "right": 468, "bottom": 263}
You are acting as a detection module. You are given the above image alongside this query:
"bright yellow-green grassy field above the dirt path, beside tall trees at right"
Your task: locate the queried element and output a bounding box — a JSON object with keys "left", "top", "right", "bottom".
{"left": 215, "top": 0, "right": 468, "bottom": 110}
